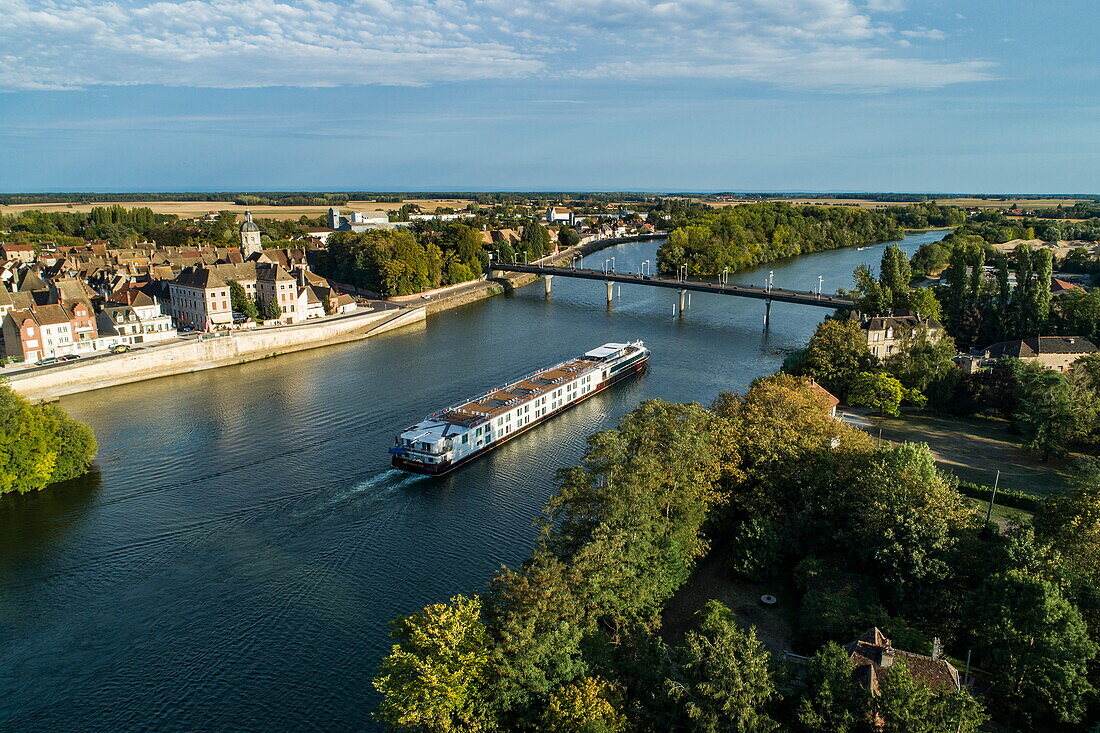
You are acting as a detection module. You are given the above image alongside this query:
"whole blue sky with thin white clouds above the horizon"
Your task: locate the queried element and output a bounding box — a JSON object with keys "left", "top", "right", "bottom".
{"left": 0, "top": 0, "right": 1100, "bottom": 194}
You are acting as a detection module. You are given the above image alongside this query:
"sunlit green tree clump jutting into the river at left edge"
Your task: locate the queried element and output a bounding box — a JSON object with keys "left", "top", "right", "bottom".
{"left": 0, "top": 384, "right": 97, "bottom": 494}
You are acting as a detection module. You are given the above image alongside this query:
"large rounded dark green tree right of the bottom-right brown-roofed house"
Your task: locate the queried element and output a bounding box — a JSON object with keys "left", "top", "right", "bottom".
{"left": 974, "top": 570, "right": 1097, "bottom": 726}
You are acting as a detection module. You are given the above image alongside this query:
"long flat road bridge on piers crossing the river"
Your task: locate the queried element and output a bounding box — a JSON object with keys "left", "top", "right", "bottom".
{"left": 491, "top": 262, "right": 856, "bottom": 328}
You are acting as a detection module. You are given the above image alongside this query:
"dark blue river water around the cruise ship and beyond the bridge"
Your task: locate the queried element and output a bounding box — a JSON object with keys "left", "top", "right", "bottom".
{"left": 0, "top": 232, "right": 944, "bottom": 731}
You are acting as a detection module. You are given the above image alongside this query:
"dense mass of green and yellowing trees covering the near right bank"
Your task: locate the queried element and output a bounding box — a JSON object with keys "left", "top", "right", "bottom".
{"left": 375, "top": 374, "right": 1100, "bottom": 733}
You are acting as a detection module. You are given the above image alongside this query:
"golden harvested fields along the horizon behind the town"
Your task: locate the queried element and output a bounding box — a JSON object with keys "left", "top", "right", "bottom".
{"left": 0, "top": 198, "right": 471, "bottom": 219}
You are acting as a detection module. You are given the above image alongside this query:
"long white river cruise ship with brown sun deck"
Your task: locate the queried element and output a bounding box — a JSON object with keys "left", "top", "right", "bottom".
{"left": 389, "top": 341, "right": 649, "bottom": 475}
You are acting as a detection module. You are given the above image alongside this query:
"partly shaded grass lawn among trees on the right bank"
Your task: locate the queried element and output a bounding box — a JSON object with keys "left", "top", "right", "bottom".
{"left": 870, "top": 415, "right": 1069, "bottom": 495}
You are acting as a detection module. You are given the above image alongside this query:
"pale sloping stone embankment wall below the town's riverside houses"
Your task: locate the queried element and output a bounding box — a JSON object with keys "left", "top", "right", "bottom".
{"left": 8, "top": 307, "right": 427, "bottom": 401}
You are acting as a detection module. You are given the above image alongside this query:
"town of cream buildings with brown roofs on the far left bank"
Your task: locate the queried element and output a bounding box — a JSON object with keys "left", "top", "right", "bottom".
{"left": 0, "top": 201, "right": 655, "bottom": 367}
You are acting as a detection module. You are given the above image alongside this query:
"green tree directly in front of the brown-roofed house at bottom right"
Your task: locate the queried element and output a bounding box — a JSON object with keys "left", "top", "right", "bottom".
{"left": 875, "top": 659, "right": 988, "bottom": 733}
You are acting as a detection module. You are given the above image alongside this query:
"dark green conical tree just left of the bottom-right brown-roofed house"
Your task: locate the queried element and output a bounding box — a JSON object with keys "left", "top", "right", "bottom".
{"left": 798, "top": 642, "right": 870, "bottom": 733}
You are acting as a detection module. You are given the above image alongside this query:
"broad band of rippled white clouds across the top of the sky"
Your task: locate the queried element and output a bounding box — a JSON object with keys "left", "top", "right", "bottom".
{"left": 0, "top": 0, "right": 990, "bottom": 89}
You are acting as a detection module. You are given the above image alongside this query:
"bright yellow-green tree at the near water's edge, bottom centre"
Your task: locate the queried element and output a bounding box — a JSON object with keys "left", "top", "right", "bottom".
{"left": 374, "top": 595, "right": 494, "bottom": 733}
